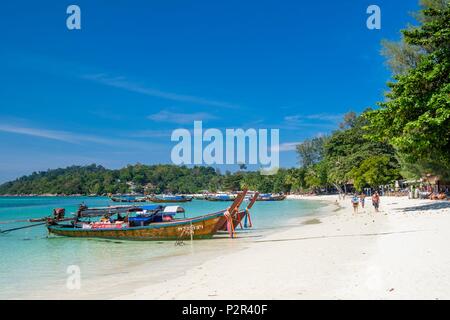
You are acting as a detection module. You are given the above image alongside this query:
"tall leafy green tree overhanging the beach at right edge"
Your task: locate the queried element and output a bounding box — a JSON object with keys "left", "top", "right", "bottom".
{"left": 366, "top": 1, "right": 450, "bottom": 175}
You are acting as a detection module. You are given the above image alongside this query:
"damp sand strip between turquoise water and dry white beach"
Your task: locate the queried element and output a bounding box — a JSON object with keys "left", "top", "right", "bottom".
{"left": 13, "top": 200, "right": 325, "bottom": 300}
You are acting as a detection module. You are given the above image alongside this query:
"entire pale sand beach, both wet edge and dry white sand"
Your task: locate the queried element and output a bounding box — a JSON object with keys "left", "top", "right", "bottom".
{"left": 5, "top": 195, "right": 450, "bottom": 300}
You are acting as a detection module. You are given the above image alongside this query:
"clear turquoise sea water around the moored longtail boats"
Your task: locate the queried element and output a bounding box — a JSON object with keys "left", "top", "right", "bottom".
{"left": 0, "top": 197, "right": 323, "bottom": 299}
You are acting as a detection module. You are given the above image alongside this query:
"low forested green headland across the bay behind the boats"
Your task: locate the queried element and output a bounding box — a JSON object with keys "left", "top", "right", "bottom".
{"left": 0, "top": 164, "right": 310, "bottom": 195}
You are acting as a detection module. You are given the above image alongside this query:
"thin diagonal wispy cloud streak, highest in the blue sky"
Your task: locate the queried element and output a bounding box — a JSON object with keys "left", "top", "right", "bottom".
{"left": 83, "top": 73, "right": 238, "bottom": 109}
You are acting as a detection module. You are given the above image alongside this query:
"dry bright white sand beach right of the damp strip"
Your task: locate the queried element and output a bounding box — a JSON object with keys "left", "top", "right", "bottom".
{"left": 116, "top": 196, "right": 450, "bottom": 299}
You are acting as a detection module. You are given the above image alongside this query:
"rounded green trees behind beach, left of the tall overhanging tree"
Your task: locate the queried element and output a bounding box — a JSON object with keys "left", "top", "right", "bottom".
{"left": 296, "top": 110, "right": 400, "bottom": 192}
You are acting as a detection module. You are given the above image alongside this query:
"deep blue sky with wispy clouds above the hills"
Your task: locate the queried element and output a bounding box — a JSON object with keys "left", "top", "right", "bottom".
{"left": 0, "top": 0, "right": 418, "bottom": 182}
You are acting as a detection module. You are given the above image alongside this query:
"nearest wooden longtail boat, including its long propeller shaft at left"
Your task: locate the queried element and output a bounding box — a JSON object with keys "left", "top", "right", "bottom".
{"left": 0, "top": 190, "right": 253, "bottom": 241}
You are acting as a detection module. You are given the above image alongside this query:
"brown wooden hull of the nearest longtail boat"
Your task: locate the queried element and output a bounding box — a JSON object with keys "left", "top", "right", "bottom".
{"left": 47, "top": 211, "right": 226, "bottom": 241}
